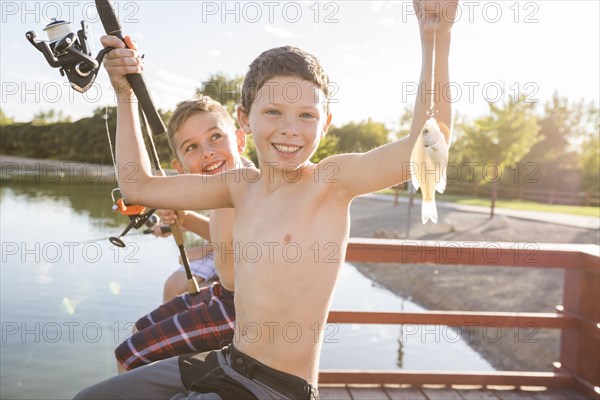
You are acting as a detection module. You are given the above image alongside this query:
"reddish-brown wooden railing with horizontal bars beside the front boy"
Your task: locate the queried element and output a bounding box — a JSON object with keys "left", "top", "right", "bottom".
{"left": 319, "top": 238, "right": 600, "bottom": 398}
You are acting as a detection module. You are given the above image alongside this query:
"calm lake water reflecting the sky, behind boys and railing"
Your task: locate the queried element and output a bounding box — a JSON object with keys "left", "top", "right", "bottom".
{"left": 0, "top": 183, "right": 493, "bottom": 399}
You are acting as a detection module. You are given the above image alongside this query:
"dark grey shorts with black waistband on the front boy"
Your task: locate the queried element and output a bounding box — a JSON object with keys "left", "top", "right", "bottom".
{"left": 75, "top": 345, "right": 319, "bottom": 400}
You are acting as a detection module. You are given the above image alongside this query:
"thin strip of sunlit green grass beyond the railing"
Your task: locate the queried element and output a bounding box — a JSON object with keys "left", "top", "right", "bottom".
{"left": 377, "top": 189, "right": 600, "bottom": 217}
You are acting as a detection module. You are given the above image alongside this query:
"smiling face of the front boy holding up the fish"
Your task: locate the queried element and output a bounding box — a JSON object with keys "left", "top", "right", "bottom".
{"left": 238, "top": 76, "right": 331, "bottom": 168}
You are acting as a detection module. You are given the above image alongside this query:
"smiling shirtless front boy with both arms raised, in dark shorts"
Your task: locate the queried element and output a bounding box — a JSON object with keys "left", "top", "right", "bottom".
{"left": 77, "top": 1, "right": 456, "bottom": 399}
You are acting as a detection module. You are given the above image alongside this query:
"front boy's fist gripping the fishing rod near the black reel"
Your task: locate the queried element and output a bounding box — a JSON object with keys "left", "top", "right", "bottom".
{"left": 100, "top": 35, "right": 144, "bottom": 94}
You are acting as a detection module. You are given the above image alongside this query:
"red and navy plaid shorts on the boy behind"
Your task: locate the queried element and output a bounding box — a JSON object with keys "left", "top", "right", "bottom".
{"left": 115, "top": 282, "right": 235, "bottom": 370}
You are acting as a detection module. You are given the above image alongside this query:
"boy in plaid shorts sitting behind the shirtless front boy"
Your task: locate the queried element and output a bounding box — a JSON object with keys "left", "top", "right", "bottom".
{"left": 115, "top": 96, "right": 251, "bottom": 372}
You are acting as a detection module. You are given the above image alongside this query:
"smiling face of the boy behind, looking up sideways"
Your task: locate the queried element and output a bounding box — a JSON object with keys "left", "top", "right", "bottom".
{"left": 171, "top": 112, "right": 246, "bottom": 175}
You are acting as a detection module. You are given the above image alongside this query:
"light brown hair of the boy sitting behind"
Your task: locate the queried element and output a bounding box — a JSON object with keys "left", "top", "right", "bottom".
{"left": 167, "top": 96, "right": 236, "bottom": 158}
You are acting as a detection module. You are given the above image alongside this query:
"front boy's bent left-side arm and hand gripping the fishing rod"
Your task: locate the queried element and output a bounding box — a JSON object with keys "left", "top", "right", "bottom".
{"left": 101, "top": 36, "right": 235, "bottom": 210}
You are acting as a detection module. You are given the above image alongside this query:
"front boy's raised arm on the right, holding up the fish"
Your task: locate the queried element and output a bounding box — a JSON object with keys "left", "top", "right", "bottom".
{"left": 332, "top": 0, "right": 458, "bottom": 197}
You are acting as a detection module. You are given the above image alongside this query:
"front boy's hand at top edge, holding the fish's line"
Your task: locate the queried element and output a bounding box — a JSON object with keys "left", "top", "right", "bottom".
{"left": 413, "top": 0, "right": 458, "bottom": 40}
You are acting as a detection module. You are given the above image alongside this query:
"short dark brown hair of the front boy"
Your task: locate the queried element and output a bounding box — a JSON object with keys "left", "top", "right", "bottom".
{"left": 242, "top": 46, "right": 331, "bottom": 114}
